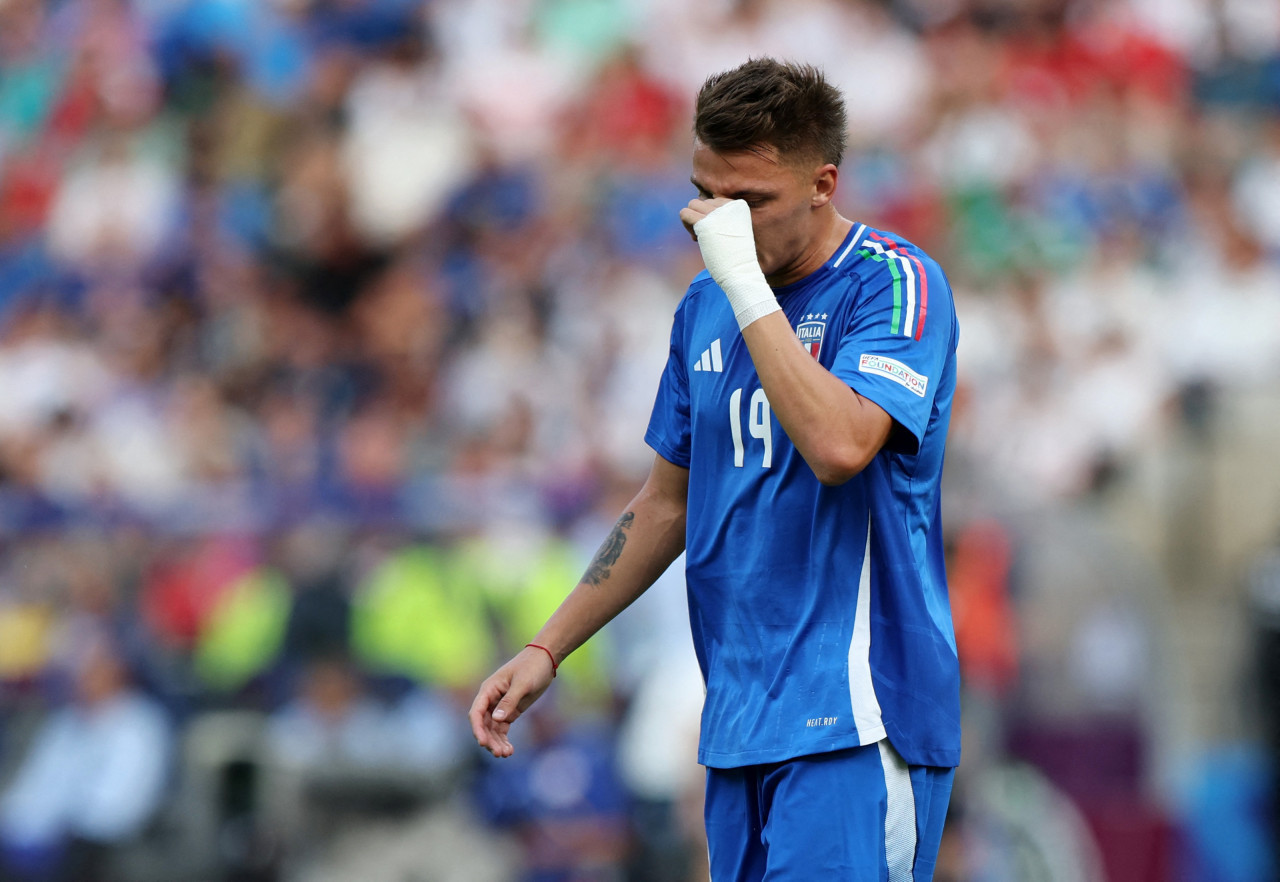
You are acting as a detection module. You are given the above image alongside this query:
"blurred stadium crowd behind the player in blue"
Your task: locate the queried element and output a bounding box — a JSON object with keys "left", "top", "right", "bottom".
{"left": 0, "top": 0, "right": 1280, "bottom": 882}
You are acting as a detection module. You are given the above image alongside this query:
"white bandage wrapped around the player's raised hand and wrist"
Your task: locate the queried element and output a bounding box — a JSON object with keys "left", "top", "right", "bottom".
{"left": 682, "top": 200, "right": 781, "bottom": 329}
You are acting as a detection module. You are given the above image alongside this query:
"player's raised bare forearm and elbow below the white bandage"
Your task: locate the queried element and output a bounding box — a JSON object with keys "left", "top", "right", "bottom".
{"left": 742, "top": 312, "right": 892, "bottom": 484}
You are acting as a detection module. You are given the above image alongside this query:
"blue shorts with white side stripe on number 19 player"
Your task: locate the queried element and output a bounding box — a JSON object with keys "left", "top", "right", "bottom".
{"left": 705, "top": 739, "right": 955, "bottom": 882}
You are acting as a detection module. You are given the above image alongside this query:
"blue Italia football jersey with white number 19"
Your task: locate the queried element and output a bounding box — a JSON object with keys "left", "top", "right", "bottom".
{"left": 645, "top": 224, "right": 960, "bottom": 768}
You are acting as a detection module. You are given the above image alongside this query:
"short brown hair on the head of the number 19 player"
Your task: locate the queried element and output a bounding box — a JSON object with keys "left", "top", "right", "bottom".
{"left": 694, "top": 58, "right": 847, "bottom": 165}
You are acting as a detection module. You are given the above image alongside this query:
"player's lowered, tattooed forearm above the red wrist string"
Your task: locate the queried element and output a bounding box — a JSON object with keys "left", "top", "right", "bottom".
{"left": 534, "top": 468, "right": 686, "bottom": 662}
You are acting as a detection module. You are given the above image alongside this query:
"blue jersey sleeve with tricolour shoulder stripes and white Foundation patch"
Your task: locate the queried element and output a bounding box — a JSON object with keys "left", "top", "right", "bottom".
{"left": 831, "top": 234, "right": 955, "bottom": 453}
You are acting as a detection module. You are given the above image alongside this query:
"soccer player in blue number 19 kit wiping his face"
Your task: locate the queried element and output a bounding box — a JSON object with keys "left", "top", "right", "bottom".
{"left": 470, "top": 59, "right": 960, "bottom": 882}
